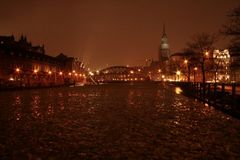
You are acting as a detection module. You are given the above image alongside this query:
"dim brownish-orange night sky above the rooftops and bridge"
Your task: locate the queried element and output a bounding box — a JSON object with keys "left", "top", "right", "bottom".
{"left": 0, "top": 0, "right": 239, "bottom": 68}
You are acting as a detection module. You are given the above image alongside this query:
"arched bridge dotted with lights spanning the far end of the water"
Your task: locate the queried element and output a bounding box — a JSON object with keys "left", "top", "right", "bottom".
{"left": 92, "top": 66, "right": 150, "bottom": 82}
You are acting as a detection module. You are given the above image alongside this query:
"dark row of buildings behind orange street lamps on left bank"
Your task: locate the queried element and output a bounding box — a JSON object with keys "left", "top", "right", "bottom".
{"left": 0, "top": 36, "right": 84, "bottom": 87}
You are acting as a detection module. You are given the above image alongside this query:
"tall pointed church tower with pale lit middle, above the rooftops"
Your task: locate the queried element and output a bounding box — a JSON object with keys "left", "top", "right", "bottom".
{"left": 158, "top": 25, "right": 170, "bottom": 62}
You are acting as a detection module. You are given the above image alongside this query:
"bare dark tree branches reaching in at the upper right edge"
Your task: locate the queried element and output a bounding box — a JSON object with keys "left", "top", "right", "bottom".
{"left": 221, "top": 5, "right": 240, "bottom": 52}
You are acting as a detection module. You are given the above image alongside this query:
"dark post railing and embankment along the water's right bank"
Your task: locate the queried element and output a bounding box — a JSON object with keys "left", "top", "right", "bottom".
{"left": 171, "top": 82, "right": 240, "bottom": 118}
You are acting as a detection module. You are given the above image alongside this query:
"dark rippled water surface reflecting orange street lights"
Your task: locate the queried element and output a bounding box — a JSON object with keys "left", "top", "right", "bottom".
{"left": 0, "top": 83, "right": 240, "bottom": 160}
